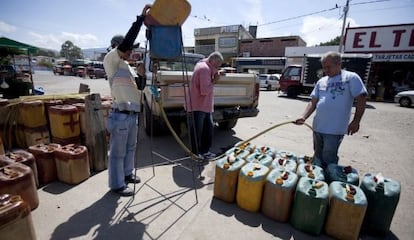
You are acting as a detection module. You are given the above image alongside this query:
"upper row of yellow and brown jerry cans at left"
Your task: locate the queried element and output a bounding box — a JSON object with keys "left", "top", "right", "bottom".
{"left": 0, "top": 98, "right": 112, "bottom": 149}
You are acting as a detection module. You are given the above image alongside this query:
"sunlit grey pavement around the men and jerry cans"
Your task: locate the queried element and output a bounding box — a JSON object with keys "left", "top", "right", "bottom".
{"left": 27, "top": 73, "right": 414, "bottom": 239}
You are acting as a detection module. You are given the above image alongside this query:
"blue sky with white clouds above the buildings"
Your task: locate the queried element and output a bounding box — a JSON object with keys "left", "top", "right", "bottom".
{"left": 0, "top": 0, "right": 414, "bottom": 51}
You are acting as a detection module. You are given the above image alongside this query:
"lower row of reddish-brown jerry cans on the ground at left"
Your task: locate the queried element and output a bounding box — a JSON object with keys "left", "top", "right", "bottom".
{"left": 0, "top": 144, "right": 90, "bottom": 210}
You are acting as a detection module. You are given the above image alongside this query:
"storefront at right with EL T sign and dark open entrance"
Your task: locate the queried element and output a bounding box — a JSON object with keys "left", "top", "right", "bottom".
{"left": 344, "top": 23, "right": 414, "bottom": 101}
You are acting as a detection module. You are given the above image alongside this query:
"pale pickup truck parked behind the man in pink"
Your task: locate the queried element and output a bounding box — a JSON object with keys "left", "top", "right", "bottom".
{"left": 143, "top": 53, "right": 259, "bottom": 135}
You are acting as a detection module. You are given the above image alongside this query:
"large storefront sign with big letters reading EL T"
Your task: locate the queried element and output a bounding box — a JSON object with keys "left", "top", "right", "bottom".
{"left": 344, "top": 24, "right": 414, "bottom": 53}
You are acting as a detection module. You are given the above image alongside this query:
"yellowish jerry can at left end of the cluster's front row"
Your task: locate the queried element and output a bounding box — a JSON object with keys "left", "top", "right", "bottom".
{"left": 214, "top": 156, "right": 246, "bottom": 203}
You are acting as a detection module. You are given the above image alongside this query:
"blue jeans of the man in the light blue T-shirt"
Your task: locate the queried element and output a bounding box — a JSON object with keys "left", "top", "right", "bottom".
{"left": 313, "top": 132, "right": 344, "bottom": 169}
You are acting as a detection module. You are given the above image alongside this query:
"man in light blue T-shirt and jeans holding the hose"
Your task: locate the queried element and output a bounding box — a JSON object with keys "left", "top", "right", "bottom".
{"left": 295, "top": 52, "right": 367, "bottom": 169}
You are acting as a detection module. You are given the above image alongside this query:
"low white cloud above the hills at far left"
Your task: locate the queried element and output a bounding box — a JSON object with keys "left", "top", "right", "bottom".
{"left": 29, "top": 32, "right": 98, "bottom": 50}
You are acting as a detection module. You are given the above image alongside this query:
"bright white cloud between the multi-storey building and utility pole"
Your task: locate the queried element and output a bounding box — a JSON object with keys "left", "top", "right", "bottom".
{"left": 300, "top": 16, "right": 357, "bottom": 46}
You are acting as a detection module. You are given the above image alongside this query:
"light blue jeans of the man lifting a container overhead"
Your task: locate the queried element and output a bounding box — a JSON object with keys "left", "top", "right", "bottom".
{"left": 108, "top": 112, "right": 138, "bottom": 189}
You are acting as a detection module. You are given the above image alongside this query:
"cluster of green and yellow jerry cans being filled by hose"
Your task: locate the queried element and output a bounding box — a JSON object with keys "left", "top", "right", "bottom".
{"left": 214, "top": 145, "right": 401, "bottom": 239}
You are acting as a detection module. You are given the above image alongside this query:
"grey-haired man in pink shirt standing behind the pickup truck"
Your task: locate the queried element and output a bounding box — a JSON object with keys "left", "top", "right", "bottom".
{"left": 185, "top": 52, "right": 223, "bottom": 160}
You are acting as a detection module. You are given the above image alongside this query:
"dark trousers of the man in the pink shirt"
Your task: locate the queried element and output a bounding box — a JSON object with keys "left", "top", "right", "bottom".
{"left": 187, "top": 111, "right": 214, "bottom": 154}
